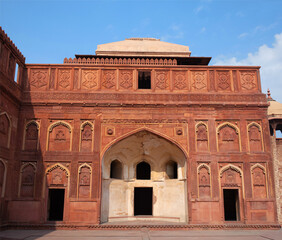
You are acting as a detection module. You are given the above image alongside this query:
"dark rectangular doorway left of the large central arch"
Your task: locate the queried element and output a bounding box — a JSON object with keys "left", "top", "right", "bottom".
{"left": 48, "top": 189, "right": 65, "bottom": 221}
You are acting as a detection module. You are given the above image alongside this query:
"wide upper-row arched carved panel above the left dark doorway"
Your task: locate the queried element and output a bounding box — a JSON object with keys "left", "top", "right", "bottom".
{"left": 49, "top": 124, "right": 71, "bottom": 151}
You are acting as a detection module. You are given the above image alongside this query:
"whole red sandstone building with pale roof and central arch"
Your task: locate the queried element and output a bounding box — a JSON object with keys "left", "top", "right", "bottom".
{"left": 0, "top": 29, "right": 282, "bottom": 227}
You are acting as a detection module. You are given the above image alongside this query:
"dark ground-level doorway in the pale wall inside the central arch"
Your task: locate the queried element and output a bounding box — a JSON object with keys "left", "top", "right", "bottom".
{"left": 134, "top": 187, "right": 153, "bottom": 216}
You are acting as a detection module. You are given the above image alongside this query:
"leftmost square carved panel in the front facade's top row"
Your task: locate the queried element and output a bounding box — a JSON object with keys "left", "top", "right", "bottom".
{"left": 29, "top": 69, "right": 48, "bottom": 90}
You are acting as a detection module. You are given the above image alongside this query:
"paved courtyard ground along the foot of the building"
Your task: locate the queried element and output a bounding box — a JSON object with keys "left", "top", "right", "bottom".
{"left": 0, "top": 228, "right": 282, "bottom": 240}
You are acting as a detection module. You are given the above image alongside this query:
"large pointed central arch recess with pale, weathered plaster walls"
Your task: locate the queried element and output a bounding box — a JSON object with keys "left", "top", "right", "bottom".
{"left": 101, "top": 130, "right": 188, "bottom": 223}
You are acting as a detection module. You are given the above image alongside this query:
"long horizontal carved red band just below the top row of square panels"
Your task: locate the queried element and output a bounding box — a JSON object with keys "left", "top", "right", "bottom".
{"left": 23, "top": 91, "right": 266, "bottom": 103}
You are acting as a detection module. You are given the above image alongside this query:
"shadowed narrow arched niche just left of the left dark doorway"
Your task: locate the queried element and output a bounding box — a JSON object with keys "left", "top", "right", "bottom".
{"left": 20, "top": 165, "right": 35, "bottom": 198}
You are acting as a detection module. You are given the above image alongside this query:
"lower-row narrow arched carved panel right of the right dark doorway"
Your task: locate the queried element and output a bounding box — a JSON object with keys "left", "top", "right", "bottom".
{"left": 252, "top": 167, "right": 267, "bottom": 199}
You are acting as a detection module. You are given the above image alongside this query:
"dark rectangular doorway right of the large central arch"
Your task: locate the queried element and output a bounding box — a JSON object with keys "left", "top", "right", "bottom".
{"left": 223, "top": 189, "right": 240, "bottom": 221}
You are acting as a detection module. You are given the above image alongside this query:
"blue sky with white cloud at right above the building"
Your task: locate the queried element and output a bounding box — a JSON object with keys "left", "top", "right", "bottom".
{"left": 0, "top": 0, "right": 282, "bottom": 102}
